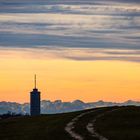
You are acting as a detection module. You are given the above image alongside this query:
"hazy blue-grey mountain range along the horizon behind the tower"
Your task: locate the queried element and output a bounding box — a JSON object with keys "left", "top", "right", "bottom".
{"left": 0, "top": 100, "right": 140, "bottom": 114}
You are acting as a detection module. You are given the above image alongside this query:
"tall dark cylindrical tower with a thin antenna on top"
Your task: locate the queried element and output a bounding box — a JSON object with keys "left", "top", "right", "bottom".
{"left": 30, "top": 75, "right": 40, "bottom": 116}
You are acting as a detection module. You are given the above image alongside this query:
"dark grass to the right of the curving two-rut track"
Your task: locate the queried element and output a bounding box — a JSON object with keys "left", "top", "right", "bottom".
{"left": 95, "top": 106, "right": 140, "bottom": 140}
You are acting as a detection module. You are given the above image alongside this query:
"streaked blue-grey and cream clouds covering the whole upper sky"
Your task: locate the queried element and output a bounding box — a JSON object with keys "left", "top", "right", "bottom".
{"left": 0, "top": 0, "right": 140, "bottom": 62}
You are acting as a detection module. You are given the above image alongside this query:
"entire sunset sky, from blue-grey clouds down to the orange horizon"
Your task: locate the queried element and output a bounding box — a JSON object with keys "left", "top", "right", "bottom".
{"left": 0, "top": 0, "right": 140, "bottom": 103}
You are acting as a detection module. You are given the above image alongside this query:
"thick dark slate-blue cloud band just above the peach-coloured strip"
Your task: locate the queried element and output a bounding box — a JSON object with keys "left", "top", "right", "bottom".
{"left": 0, "top": 32, "right": 139, "bottom": 49}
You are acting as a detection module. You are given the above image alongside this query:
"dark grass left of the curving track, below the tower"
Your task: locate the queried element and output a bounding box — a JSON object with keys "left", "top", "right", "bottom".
{"left": 0, "top": 112, "right": 80, "bottom": 140}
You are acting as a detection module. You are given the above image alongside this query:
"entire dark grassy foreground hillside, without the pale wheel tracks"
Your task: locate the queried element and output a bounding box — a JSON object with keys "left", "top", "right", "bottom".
{"left": 0, "top": 107, "right": 140, "bottom": 140}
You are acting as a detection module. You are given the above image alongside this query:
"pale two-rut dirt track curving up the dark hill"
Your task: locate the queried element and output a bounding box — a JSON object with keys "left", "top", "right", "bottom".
{"left": 65, "top": 109, "right": 118, "bottom": 140}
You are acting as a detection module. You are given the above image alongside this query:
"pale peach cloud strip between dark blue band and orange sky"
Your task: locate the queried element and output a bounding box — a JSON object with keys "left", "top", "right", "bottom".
{"left": 0, "top": 46, "right": 140, "bottom": 62}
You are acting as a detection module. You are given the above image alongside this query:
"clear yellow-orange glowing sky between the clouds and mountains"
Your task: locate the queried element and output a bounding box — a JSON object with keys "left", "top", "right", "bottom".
{"left": 0, "top": 51, "right": 140, "bottom": 102}
